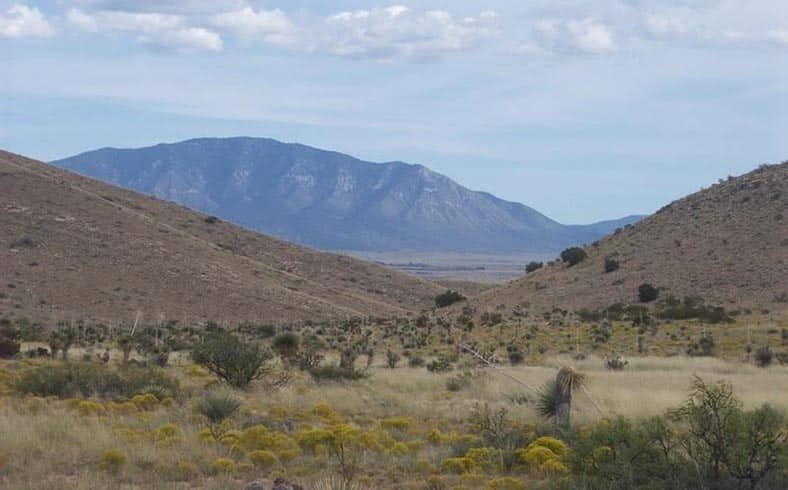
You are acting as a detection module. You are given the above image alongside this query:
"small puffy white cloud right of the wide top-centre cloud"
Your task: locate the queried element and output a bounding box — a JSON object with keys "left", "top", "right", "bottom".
{"left": 522, "top": 18, "right": 616, "bottom": 55}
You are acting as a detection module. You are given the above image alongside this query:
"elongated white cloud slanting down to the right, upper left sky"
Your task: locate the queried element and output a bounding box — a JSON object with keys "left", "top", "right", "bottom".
{"left": 66, "top": 9, "right": 223, "bottom": 52}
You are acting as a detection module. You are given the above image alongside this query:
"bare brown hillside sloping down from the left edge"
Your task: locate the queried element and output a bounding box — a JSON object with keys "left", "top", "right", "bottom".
{"left": 0, "top": 151, "right": 442, "bottom": 323}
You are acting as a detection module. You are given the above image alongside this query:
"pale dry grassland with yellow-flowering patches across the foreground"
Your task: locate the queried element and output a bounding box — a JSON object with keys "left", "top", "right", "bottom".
{"left": 0, "top": 355, "right": 788, "bottom": 489}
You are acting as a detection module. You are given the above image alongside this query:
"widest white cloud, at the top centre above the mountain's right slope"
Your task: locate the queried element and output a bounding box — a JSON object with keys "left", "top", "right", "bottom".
{"left": 318, "top": 5, "right": 496, "bottom": 60}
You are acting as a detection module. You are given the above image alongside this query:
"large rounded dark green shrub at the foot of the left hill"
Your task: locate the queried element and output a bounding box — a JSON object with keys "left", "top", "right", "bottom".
{"left": 192, "top": 331, "right": 272, "bottom": 389}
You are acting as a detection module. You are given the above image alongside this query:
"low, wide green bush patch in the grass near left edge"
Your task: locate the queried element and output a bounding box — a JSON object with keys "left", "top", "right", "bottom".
{"left": 15, "top": 362, "right": 179, "bottom": 399}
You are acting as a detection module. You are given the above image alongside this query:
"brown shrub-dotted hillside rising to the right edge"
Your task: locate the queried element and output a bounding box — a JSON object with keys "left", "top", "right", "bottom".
{"left": 471, "top": 163, "right": 788, "bottom": 311}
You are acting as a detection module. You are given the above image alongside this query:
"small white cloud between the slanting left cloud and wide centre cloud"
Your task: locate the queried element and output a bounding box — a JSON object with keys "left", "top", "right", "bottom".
{"left": 213, "top": 7, "right": 295, "bottom": 44}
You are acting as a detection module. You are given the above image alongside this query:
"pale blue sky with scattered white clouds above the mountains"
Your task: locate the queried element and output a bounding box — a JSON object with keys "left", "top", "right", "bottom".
{"left": 0, "top": 0, "right": 788, "bottom": 223}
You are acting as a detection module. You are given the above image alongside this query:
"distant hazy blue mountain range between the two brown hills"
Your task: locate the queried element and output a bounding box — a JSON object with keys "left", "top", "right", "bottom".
{"left": 53, "top": 138, "right": 641, "bottom": 253}
